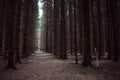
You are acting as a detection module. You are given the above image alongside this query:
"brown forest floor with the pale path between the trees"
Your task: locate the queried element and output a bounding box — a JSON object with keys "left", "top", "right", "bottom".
{"left": 0, "top": 53, "right": 120, "bottom": 80}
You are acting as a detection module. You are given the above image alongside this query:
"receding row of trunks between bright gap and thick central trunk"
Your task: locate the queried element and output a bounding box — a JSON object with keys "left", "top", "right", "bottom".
{"left": 44, "top": 0, "right": 67, "bottom": 59}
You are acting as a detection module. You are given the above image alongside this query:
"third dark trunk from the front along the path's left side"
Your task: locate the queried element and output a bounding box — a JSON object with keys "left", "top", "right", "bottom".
{"left": 23, "top": 0, "right": 31, "bottom": 58}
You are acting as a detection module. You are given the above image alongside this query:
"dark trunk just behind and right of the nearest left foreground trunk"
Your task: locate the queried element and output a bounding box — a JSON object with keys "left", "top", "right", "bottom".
{"left": 15, "top": 1, "right": 22, "bottom": 63}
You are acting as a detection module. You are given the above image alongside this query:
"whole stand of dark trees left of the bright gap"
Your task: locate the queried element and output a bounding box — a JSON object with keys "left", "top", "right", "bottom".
{"left": 0, "top": 0, "right": 38, "bottom": 69}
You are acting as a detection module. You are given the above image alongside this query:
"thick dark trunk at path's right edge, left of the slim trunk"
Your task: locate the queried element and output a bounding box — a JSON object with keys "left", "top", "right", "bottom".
{"left": 61, "top": 0, "right": 67, "bottom": 59}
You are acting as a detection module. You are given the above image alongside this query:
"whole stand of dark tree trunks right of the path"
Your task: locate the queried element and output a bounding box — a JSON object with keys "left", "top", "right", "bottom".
{"left": 45, "top": 0, "right": 119, "bottom": 66}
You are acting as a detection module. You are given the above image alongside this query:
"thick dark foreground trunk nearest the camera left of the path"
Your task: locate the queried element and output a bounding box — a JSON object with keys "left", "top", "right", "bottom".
{"left": 6, "top": 0, "right": 16, "bottom": 69}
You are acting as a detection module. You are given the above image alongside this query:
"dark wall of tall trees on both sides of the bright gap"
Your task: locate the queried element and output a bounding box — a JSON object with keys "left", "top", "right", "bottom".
{"left": 0, "top": 0, "right": 120, "bottom": 69}
